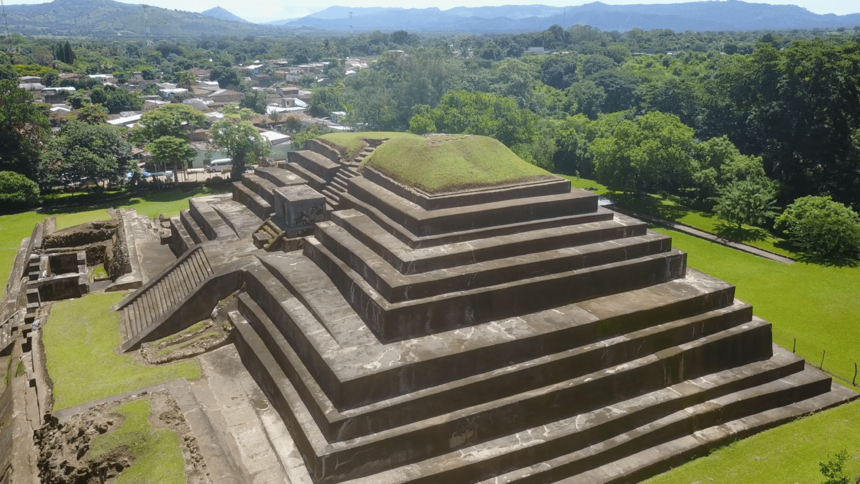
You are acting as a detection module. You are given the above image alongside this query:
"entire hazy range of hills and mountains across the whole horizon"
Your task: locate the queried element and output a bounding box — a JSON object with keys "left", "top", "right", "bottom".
{"left": 6, "top": 0, "right": 860, "bottom": 39}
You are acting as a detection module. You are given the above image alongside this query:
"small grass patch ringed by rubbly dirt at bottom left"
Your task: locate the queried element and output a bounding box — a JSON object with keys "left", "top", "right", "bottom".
{"left": 90, "top": 399, "right": 185, "bottom": 484}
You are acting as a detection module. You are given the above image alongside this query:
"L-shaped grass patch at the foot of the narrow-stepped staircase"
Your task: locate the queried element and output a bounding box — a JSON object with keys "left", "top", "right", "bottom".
{"left": 43, "top": 293, "right": 200, "bottom": 410}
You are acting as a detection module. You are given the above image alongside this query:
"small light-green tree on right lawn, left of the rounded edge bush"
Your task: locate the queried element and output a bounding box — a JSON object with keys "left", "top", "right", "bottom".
{"left": 714, "top": 178, "right": 777, "bottom": 230}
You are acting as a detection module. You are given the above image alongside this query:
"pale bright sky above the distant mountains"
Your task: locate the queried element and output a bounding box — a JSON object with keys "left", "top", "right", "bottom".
{"left": 5, "top": 0, "right": 860, "bottom": 23}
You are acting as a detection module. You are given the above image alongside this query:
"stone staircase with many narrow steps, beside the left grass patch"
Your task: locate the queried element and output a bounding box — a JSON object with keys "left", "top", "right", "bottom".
{"left": 119, "top": 247, "right": 214, "bottom": 349}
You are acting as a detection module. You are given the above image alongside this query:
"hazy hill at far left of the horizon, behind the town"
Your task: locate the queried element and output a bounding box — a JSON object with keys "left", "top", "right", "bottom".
{"left": 6, "top": 0, "right": 272, "bottom": 39}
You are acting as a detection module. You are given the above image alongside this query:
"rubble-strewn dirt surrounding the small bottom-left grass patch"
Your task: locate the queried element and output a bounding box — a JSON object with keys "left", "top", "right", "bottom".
{"left": 33, "top": 391, "right": 211, "bottom": 484}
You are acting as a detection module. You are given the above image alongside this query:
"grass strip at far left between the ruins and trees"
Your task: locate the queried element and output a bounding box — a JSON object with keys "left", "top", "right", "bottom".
{"left": 0, "top": 189, "right": 227, "bottom": 296}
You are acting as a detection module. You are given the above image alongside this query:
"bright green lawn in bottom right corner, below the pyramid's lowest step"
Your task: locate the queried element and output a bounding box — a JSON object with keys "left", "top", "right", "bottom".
{"left": 645, "top": 402, "right": 860, "bottom": 484}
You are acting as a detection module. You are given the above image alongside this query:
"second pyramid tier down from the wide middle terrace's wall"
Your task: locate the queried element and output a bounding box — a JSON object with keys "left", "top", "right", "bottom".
{"left": 231, "top": 306, "right": 788, "bottom": 482}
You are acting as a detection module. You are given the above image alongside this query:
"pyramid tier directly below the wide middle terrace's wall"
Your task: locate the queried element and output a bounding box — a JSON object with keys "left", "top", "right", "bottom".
{"left": 239, "top": 288, "right": 764, "bottom": 440}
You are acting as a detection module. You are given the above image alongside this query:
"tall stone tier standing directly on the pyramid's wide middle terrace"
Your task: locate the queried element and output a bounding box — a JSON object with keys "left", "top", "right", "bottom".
{"left": 304, "top": 237, "right": 687, "bottom": 342}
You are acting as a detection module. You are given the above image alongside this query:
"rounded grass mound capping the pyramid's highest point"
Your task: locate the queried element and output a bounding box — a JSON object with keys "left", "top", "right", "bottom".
{"left": 363, "top": 135, "right": 554, "bottom": 194}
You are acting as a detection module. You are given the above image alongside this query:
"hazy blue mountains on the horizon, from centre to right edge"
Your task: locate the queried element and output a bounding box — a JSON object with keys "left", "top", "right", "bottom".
{"left": 280, "top": 0, "right": 860, "bottom": 32}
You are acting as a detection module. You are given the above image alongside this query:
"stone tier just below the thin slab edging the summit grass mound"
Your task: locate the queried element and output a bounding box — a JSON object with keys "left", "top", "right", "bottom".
{"left": 348, "top": 177, "right": 598, "bottom": 237}
